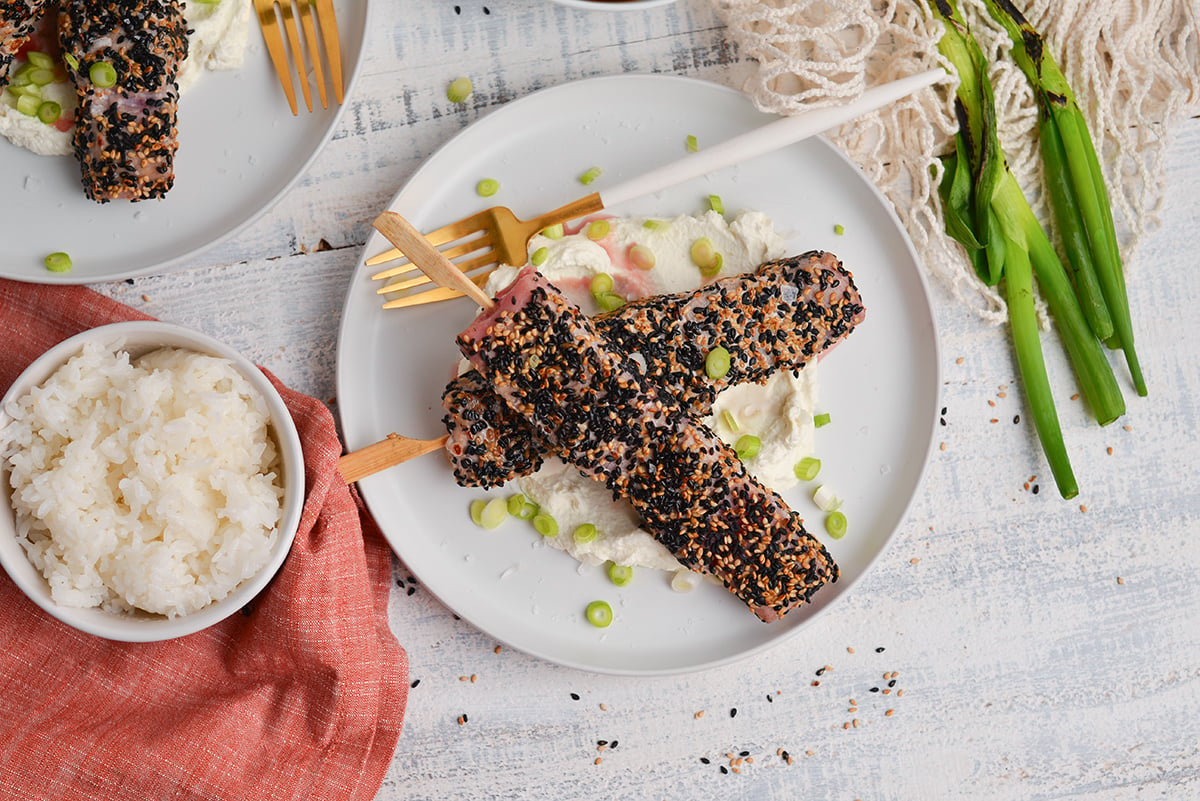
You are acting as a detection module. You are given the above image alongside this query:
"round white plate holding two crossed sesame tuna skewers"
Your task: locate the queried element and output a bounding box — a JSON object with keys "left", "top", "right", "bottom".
{"left": 337, "top": 76, "right": 940, "bottom": 675}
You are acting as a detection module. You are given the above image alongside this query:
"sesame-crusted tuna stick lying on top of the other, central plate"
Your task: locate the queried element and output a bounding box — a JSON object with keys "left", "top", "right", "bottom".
{"left": 458, "top": 267, "right": 838, "bottom": 621}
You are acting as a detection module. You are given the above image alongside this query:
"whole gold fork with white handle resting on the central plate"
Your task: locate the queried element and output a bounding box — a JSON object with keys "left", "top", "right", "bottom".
{"left": 366, "top": 68, "right": 949, "bottom": 308}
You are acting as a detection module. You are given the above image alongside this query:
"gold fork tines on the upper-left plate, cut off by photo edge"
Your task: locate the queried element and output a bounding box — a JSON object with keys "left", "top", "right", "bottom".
{"left": 254, "top": 0, "right": 344, "bottom": 115}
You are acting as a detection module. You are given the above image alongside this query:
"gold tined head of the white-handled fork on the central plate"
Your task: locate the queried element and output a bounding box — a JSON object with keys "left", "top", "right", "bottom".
{"left": 367, "top": 193, "right": 604, "bottom": 308}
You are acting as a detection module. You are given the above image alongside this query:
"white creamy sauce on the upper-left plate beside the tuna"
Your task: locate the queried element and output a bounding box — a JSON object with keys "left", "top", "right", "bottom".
{"left": 0, "top": 0, "right": 252, "bottom": 156}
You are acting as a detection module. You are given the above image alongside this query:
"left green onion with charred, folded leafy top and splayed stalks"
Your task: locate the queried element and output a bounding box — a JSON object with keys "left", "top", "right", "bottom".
{"left": 931, "top": 0, "right": 1124, "bottom": 498}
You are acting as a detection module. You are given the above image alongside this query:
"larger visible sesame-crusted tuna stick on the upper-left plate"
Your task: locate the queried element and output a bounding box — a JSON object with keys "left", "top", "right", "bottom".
{"left": 59, "top": 0, "right": 187, "bottom": 203}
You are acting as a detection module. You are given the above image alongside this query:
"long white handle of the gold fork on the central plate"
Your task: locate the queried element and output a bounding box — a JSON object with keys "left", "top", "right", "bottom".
{"left": 600, "top": 68, "right": 949, "bottom": 209}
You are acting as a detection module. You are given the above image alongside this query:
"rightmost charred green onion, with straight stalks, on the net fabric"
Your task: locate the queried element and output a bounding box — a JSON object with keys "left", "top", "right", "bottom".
{"left": 985, "top": 0, "right": 1147, "bottom": 396}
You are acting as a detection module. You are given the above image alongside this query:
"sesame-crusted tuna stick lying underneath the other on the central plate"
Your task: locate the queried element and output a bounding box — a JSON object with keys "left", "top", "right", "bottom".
{"left": 442, "top": 251, "right": 864, "bottom": 487}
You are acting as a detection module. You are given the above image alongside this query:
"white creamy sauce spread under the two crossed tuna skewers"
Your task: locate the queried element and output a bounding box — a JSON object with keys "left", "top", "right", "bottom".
{"left": 485, "top": 211, "right": 817, "bottom": 577}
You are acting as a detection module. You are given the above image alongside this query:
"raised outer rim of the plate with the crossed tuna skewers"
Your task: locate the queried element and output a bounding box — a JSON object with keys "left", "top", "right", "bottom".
{"left": 337, "top": 73, "right": 942, "bottom": 676}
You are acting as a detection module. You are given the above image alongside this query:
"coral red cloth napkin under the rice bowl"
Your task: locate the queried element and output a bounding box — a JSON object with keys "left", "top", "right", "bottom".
{"left": 0, "top": 279, "right": 408, "bottom": 801}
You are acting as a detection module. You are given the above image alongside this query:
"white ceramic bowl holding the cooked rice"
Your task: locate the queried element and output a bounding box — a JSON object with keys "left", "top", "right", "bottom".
{"left": 0, "top": 321, "right": 305, "bottom": 643}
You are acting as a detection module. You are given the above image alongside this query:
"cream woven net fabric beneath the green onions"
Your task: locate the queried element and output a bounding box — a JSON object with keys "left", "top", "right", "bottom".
{"left": 714, "top": 0, "right": 1200, "bottom": 324}
